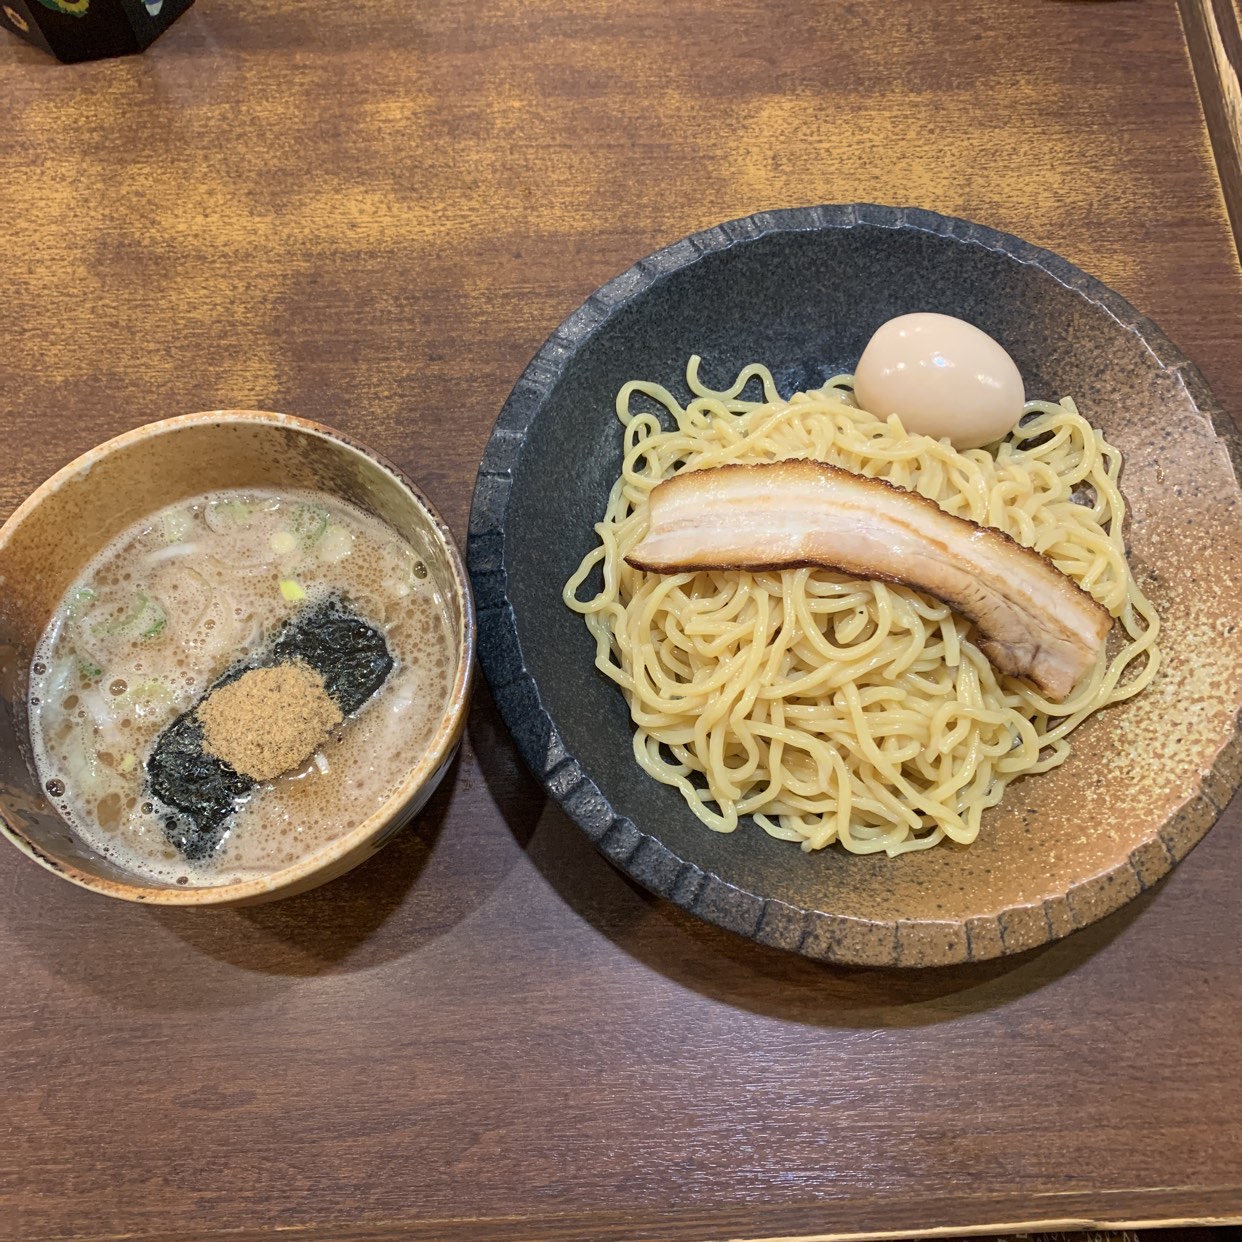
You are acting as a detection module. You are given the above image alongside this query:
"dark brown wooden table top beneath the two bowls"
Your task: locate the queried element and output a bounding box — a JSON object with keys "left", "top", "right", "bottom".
{"left": 0, "top": 0, "right": 1242, "bottom": 1242}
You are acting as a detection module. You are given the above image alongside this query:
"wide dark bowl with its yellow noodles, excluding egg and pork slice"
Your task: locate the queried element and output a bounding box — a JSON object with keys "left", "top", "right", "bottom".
{"left": 468, "top": 206, "right": 1242, "bottom": 966}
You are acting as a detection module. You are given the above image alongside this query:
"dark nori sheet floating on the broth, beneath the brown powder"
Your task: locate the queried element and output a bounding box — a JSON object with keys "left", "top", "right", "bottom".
{"left": 147, "top": 597, "right": 392, "bottom": 862}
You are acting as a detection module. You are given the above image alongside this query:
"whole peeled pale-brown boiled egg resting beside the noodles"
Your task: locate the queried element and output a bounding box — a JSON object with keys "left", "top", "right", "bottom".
{"left": 854, "top": 313, "right": 1026, "bottom": 448}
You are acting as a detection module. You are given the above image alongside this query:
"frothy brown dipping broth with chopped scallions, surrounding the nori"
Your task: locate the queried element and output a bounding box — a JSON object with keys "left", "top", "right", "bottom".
{"left": 30, "top": 491, "right": 457, "bottom": 886}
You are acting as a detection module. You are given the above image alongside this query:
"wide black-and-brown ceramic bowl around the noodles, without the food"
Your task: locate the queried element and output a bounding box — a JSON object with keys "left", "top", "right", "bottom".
{"left": 468, "top": 206, "right": 1242, "bottom": 965}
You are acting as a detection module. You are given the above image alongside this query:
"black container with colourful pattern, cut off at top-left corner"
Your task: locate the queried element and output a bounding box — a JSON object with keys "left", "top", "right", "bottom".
{"left": 0, "top": 0, "right": 194, "bottom": 61}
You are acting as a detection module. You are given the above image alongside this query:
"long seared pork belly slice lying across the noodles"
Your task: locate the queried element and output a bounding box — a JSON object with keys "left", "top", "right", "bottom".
{"left": 626, "top": 461, "right": 1113, "bottom": 702}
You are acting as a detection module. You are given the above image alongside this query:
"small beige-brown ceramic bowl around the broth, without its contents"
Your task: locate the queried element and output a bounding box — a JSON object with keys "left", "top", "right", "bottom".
{"left": 0, "top": 410, "right": 474, "bottom": 905}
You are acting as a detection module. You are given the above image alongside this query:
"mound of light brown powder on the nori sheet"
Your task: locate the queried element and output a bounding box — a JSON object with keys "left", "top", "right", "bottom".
{"left": 196, "top": 661, "right": 343, "bottom": 780}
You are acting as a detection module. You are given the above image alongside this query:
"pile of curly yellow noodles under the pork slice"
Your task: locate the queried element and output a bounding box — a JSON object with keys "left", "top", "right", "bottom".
{"left": 564, "top": 356, "right": 1160, "bottom": 856}
